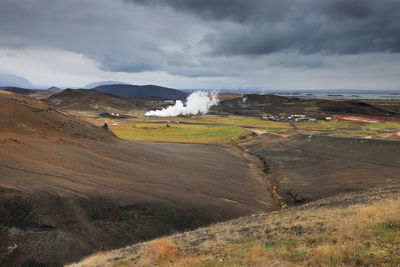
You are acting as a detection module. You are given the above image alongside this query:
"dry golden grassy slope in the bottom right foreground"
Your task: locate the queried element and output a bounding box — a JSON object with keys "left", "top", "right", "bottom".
{"left": 69, "top": 188, "right": 400, "bottom": 266}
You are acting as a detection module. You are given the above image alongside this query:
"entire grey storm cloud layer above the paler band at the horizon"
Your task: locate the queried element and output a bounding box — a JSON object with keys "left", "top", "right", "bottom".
{"left": 0, "top": 0, "right": 400, "bottom": 80}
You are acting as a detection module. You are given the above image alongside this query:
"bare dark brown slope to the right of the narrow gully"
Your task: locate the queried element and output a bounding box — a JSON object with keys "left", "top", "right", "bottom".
{"left": 241, "top": 134, "right": 400, "bottom": 205}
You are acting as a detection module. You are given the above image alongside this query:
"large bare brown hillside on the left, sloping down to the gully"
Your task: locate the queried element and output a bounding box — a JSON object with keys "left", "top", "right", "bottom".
{"left": 0, "top": 91, "right": 276, "bottom": 266}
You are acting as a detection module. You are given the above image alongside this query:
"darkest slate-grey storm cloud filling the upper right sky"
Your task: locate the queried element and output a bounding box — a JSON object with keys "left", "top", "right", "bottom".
{"left": 127, "top": 0, "right": 400, "bottom": 55}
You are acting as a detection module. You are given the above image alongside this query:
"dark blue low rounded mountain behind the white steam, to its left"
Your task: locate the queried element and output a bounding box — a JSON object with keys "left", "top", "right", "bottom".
{"left": 93, "top": 84, "right": 188, "bottom": 100}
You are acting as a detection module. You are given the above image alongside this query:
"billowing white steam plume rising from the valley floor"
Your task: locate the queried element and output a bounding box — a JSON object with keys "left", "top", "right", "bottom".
{"left": 144, "top": 91, "right": 219, "bottom": 117}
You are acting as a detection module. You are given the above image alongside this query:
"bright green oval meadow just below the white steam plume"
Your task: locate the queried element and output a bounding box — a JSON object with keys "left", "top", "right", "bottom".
{"left": 110, "top": 123, "right": 246, "bottom": 143}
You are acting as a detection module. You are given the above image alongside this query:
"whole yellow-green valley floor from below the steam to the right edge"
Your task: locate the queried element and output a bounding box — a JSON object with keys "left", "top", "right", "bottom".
{"left": 106, "top": 116, "right": 400, "bottom": 143}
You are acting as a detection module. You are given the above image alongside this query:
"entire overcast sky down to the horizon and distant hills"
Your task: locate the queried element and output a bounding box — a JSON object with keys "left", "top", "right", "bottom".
{"left": 0, "top": 0, "right": 400, "bottom": 90}
